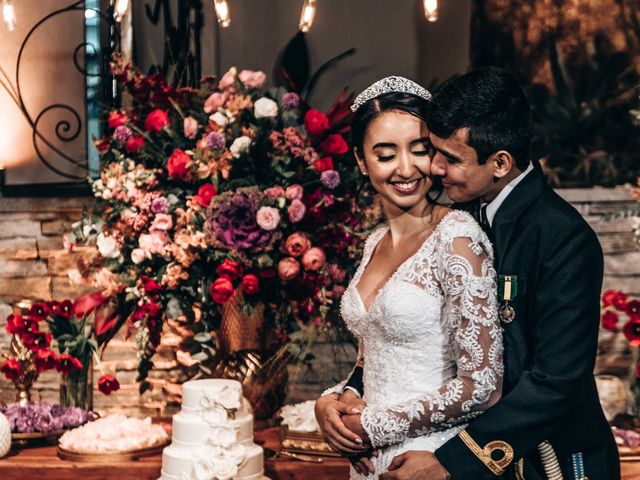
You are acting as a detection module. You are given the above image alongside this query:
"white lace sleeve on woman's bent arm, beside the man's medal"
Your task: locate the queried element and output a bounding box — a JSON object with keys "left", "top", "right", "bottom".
{"left": 361, "top": 224, "right": 503, "bottom": 447}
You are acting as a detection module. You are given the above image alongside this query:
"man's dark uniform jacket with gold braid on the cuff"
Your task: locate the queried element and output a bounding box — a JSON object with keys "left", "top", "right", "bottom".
{"left": 349, "top": 164, "right": 620, "bottom": 480}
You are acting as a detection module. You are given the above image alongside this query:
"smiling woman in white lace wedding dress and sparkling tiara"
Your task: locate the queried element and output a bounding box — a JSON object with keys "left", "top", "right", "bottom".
{"left": 316, "top": 77, "right": 503, "bottom": 479}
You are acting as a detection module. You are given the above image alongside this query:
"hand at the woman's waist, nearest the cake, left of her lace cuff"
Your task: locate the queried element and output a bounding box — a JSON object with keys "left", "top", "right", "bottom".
{"left": 315, "top": 394, "right": 367, "bottom": 455}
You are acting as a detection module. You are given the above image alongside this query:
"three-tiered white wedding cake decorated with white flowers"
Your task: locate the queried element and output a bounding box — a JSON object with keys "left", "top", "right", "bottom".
{"left": 161, "top": 379, "right": 268, "bottom": 480}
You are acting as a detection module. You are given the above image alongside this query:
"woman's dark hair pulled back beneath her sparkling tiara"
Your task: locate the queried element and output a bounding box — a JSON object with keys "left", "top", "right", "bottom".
{"left": 351, "top": 92, "right": 442, "bottom": 205}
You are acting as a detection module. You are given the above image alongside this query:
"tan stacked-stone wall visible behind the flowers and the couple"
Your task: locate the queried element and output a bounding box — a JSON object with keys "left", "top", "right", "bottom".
{"left": 0, "top": 187, "right": 640, "bottom": 415}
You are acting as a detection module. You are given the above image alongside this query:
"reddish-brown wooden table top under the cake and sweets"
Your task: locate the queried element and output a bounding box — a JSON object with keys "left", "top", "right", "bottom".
{"left": 0, "top": 428, "right": 640, "bottom": 480}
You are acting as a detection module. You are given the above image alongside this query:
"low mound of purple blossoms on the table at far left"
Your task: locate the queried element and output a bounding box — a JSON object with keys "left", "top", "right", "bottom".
{"left": 0, "top": 402, "right": 94, "bottom": 433}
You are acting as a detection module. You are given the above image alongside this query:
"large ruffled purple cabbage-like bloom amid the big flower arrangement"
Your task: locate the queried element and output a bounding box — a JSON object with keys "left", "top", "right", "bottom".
{"left": 209, "top": 188, "right": 272, "bottom": 253}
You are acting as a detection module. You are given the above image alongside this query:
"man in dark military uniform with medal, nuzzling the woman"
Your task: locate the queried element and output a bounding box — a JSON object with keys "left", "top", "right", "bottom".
{"left": 321, "top": 68, "right": 620, "bottom": 480}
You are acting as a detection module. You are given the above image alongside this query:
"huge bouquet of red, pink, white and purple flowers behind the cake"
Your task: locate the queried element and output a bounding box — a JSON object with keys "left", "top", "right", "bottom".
{"left": 72, "top": 58, "right": 371, "bottom": 388}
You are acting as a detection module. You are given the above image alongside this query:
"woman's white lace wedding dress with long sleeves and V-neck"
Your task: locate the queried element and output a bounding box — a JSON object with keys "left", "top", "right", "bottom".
{"left": 325, "top": 210, "right": 503, "bottom": 480}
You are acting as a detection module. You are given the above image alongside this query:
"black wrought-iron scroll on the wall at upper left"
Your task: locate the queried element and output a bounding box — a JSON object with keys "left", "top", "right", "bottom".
{"left": 0, "top": 0, "right": 119, "bottom": 182}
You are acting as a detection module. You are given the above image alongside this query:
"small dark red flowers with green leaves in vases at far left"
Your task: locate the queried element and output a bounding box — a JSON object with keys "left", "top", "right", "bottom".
{"left": 0, "top": 297, "right": 120, "bottom": 402}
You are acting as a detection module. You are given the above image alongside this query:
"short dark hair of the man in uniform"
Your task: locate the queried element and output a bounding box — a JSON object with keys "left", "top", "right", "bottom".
{"left": 427, "top": 67, "right": 532, "bottom": 170}
